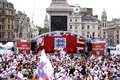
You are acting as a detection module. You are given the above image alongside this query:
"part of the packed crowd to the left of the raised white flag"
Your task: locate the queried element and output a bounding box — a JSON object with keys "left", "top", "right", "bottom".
{"left": 0, "top": 54, "right": 38, "bottom": 80}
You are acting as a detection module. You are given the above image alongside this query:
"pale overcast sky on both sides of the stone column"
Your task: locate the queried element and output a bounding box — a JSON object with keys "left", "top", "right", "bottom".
{"left": 8, "top": 0, "right": 120, "bottom": 27}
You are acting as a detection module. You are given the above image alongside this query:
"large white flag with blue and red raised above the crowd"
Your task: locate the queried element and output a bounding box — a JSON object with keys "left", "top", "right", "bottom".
{"left": 38, "top": 50, "right": 54, "bottom": 80}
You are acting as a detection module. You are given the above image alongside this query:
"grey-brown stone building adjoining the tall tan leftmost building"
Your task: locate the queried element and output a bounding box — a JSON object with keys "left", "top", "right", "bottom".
{"left": 15, "top": 11, "right": 32, "bottom": 40}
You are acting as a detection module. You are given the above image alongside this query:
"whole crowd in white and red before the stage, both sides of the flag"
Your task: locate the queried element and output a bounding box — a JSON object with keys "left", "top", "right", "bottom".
{"left": 0, "top": 51, "right": 120, "bottom": 80}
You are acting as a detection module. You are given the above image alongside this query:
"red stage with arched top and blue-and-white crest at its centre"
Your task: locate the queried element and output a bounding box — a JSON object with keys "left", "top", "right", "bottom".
{"left": 34, "top": 31, "right": 85, "bottom": 53}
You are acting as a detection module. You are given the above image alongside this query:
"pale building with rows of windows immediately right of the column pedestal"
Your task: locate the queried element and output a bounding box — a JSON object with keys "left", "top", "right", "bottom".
{"left": 69, "top": 6, "right": 101, "bottom": 38}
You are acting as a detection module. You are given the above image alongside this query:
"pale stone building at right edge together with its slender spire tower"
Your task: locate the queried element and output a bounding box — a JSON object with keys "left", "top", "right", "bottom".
{"left": 100, "top": 10, "right": 120, "bottom": 46}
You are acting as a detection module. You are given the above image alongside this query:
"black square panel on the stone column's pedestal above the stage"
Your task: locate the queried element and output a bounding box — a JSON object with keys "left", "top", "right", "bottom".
{"left": 51, "top": 16, "right": 67, "bottom": 31}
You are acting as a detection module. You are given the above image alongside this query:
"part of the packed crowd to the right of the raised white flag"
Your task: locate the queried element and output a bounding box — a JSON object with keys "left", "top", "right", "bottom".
{"left": 48, "top": 52, "right": 120, "bottom": 80}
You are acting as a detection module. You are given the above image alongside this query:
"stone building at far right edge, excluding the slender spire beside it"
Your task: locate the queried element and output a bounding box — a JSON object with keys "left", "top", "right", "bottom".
{"left": 106, "top": 19, "right": 120, "bottom": 46}
